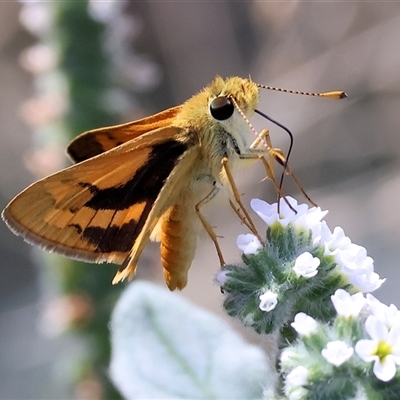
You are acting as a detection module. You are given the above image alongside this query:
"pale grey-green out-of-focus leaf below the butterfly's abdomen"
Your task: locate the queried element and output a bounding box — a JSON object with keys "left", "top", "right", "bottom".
{"left": 110, "top": 281, "right": 274, "bottom": 399}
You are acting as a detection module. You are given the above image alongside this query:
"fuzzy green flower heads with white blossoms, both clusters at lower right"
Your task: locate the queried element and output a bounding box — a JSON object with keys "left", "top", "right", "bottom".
{"left": 222, "top": 197, "right": 400, "bottom": 400}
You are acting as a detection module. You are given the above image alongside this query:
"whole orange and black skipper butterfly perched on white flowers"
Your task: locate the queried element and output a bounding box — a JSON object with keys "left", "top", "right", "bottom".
{"left": 2, "top": 76, "right": 345, "bottom": 290}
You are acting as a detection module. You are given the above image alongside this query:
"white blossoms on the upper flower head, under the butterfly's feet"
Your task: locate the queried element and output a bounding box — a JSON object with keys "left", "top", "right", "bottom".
{"left": 237, "top": 196, "right": 385, "bottom": 304}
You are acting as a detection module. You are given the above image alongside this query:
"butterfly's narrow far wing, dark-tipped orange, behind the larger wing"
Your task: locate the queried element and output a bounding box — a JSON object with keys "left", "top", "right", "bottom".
{"left": 67, "top": 106, "right": 182, "bottom": 162}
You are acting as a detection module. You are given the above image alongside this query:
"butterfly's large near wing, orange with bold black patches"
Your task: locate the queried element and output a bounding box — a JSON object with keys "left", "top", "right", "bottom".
{"left": 3, "top": 127, "right": 189, "bottom": 263}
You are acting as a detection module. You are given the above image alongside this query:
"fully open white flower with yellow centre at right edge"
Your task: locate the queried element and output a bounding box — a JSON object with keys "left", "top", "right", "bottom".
{"left": 355, "top": 315, "right": 400, "bottom": 382}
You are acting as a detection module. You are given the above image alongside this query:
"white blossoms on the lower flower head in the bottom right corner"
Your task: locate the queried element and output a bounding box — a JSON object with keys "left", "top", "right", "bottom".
{"left": 281, "top": 289, "right": 400, "bottom": 399}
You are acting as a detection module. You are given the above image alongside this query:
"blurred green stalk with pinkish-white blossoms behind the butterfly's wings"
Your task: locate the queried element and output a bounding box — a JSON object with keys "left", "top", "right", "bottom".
{"left": 17, "top": 1, "right": 155, "bottom": 399}
